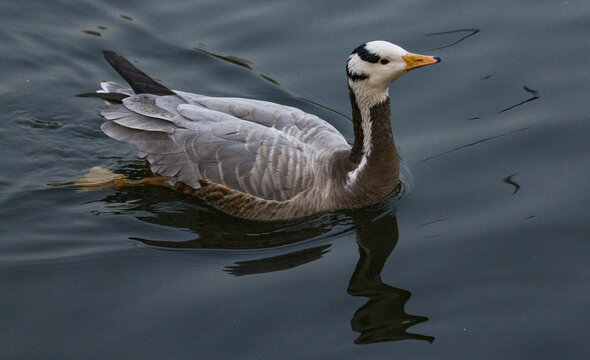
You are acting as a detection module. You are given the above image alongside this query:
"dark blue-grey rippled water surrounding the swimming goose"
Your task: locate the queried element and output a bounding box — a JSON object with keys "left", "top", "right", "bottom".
{"left": 0, "top": 0, "right": 590, "bottom": 359}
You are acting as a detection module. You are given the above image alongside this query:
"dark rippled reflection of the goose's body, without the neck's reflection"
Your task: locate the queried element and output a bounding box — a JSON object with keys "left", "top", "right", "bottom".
{"left": 97, "top": 181, "right": 354, "bottom": 255}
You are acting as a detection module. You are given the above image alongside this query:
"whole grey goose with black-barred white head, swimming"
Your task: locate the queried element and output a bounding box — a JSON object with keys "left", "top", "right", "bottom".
{"left": 79, "top": 41, "right": 440, "bottom": 221}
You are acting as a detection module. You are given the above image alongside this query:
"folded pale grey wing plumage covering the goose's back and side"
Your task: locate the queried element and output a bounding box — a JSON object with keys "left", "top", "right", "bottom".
{"left": 96, "top": 83, "right": 350, "bottom": 200}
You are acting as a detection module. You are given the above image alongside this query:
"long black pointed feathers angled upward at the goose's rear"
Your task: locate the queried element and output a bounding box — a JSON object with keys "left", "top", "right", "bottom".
{"left": 99, "top": 50, "right": 174, "bottom": 96}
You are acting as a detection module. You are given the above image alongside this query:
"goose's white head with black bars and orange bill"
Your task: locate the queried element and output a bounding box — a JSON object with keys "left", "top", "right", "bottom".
{"left": 346, "top": 41, "right": 440, "bottom": 105}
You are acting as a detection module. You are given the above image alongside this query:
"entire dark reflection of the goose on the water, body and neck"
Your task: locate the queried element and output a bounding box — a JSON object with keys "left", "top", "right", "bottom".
{"left": 88, "top": 177, "right": 434, "bottom": 344}
